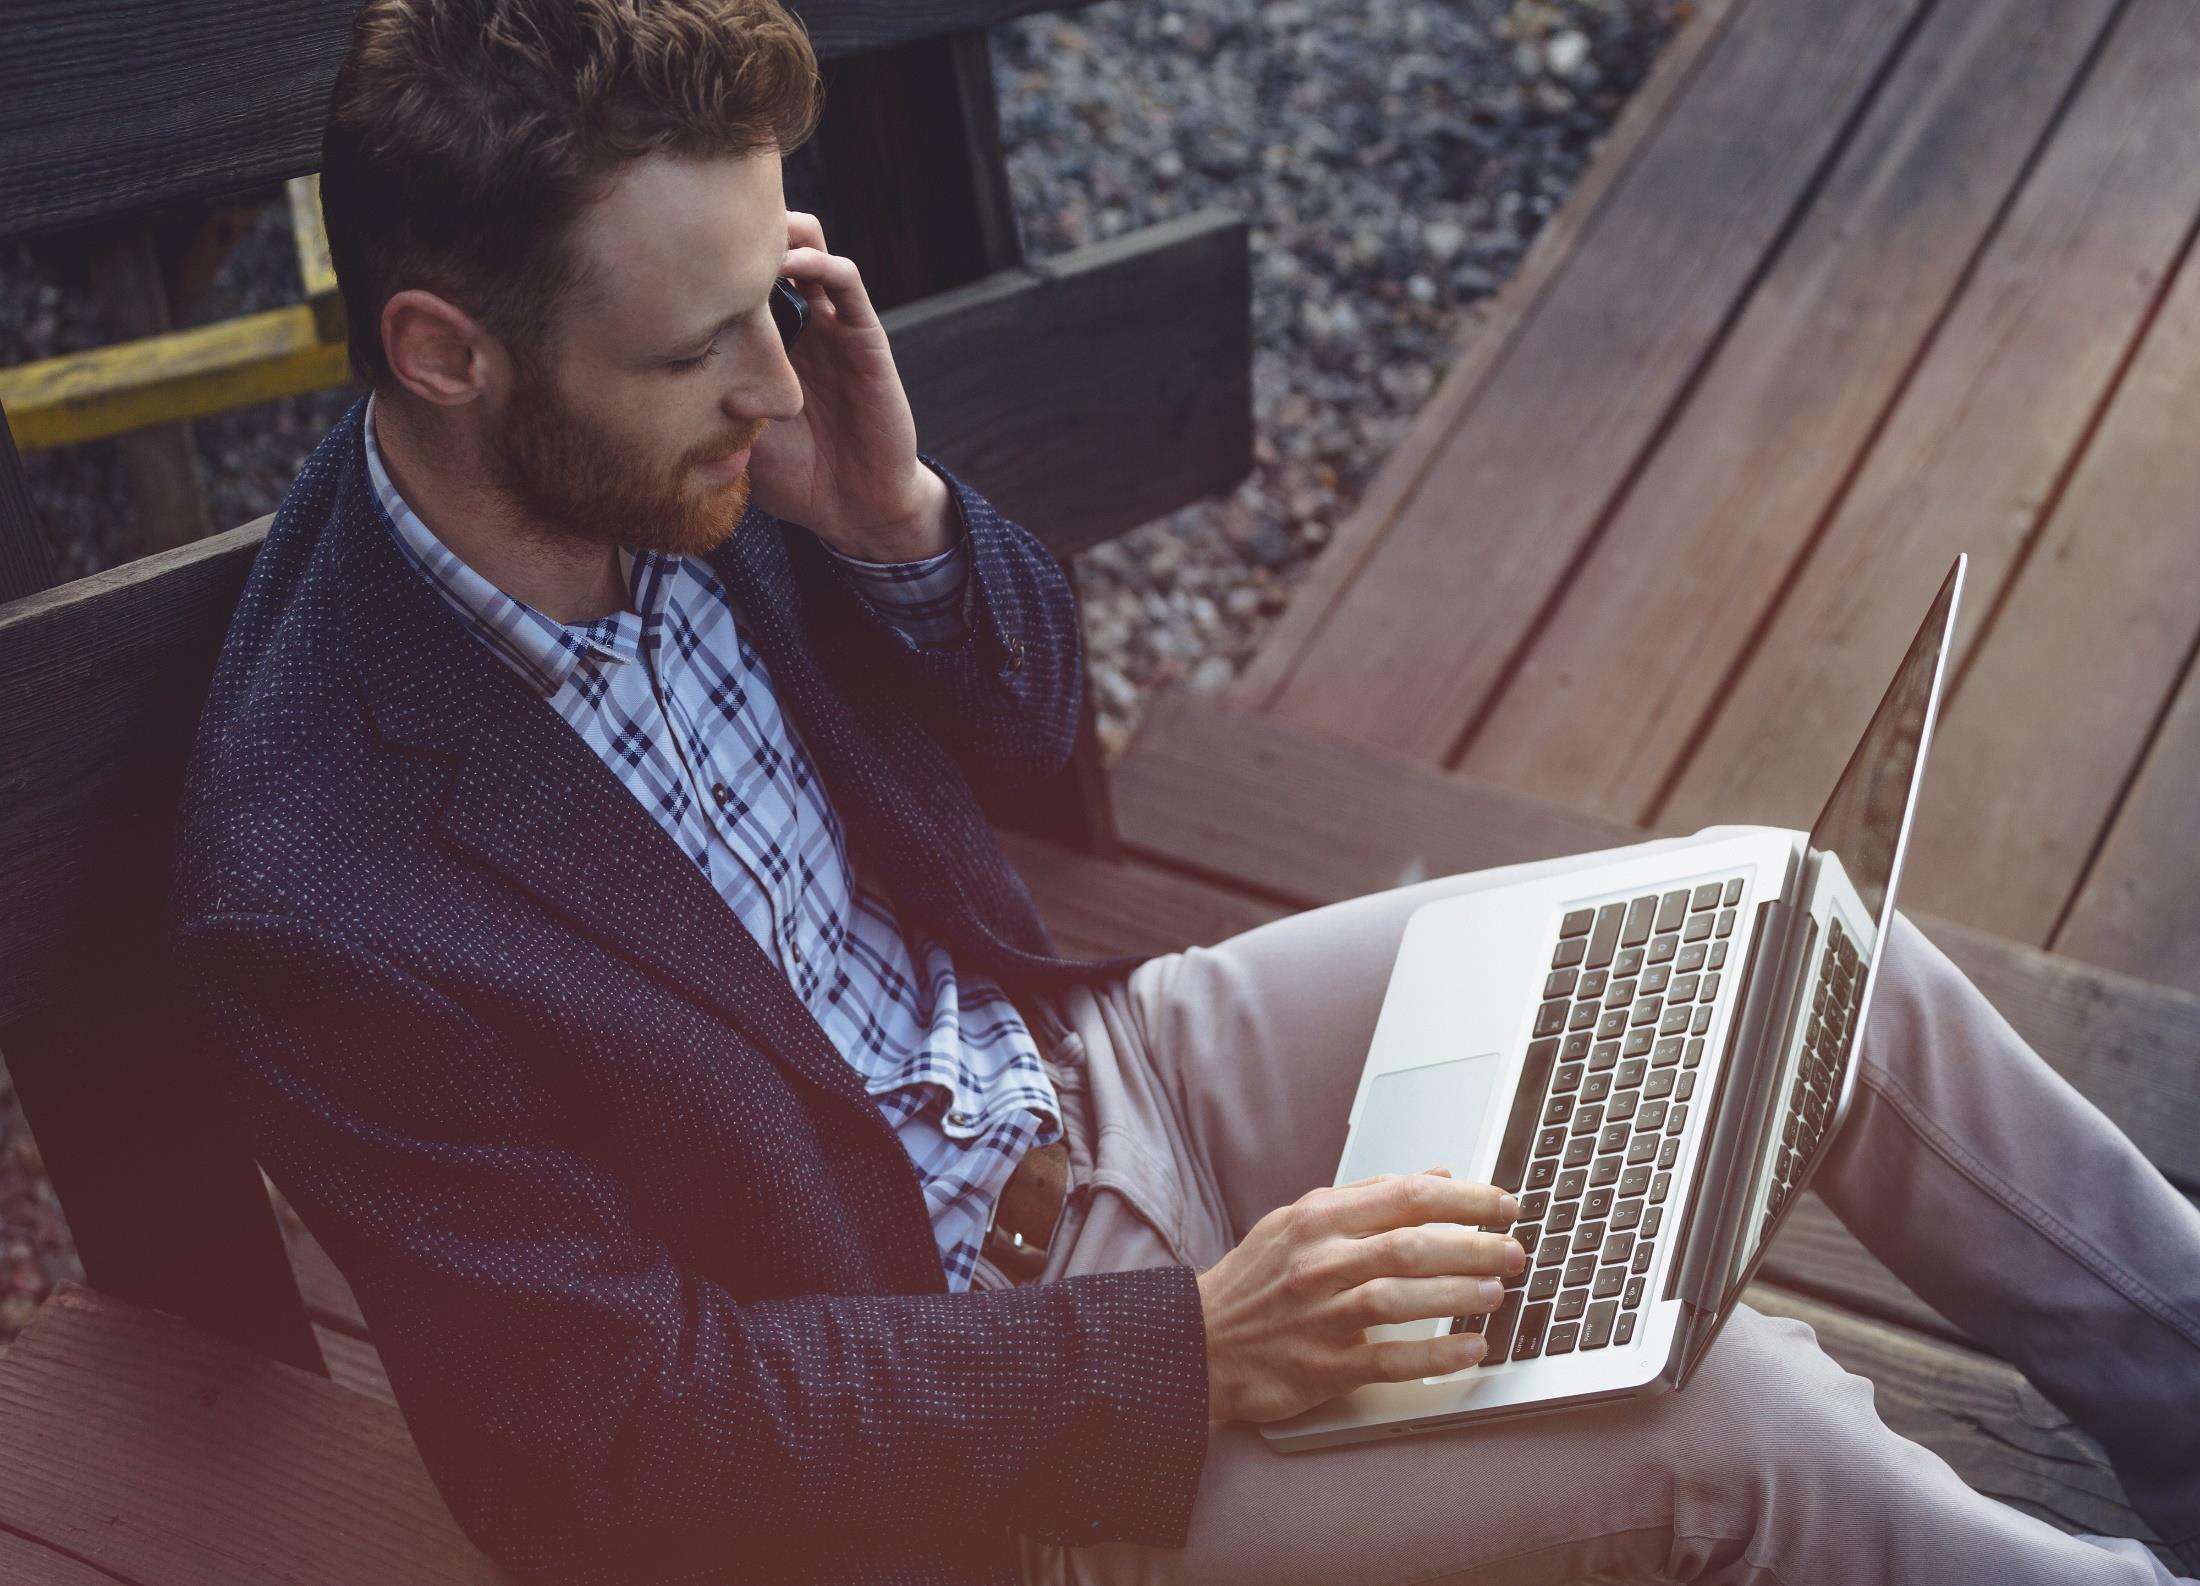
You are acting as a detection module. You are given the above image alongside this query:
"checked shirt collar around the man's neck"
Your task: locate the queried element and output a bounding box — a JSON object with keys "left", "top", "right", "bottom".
{"left": 365, "top": 394, "right": 678, "bottom": 700}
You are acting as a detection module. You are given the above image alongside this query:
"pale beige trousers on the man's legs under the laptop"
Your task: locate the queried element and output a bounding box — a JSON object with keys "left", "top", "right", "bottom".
{"left": 1003, "top": 827, "right": 2200, "bottom": 1586}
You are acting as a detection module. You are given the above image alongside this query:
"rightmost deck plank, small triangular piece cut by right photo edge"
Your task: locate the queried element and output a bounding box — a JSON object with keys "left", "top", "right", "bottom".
{"left": 2055, "top": 642, "right": 2200, "bottom": 992}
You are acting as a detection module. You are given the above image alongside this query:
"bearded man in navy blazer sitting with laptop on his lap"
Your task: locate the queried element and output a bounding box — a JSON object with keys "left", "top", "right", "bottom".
{"left": 176, "top": 0, "right": 2200, "bottom": 1584}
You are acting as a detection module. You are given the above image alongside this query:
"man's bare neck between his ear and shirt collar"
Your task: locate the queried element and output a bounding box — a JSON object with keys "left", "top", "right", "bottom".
{"left": 374, "top": 396, "right": 631, "bottom": 623}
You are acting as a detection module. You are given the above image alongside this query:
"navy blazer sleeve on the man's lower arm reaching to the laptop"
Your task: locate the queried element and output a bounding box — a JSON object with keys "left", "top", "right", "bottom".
{"left": 174, "top": 915, "right": 1208, "bottom": 1575}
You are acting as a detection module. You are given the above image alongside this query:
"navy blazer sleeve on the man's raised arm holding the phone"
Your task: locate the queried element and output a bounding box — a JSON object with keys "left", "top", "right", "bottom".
{"left": 788, "top": 453, "right": 1085, "bottom": 792}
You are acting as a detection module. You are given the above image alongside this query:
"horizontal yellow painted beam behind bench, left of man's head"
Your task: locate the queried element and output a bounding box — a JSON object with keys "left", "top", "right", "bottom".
{"left": 0, "top": 304, "right": 350, "bottom": 451}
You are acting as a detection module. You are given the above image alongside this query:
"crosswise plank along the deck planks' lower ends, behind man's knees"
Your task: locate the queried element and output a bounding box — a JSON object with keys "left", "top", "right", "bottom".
{"left": 1115, "top": 691, "right": 2200, "bottom": 1190}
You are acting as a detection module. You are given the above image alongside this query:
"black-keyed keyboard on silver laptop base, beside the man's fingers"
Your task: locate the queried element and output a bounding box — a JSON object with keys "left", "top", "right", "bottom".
{"left": 1452, "top": 875, "right": 1742, "bottom": 1366}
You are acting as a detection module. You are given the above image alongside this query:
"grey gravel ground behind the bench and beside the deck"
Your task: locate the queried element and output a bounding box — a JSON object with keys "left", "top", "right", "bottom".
{"left": 0, "top": 0, "right": 1687, "bottom": 1340}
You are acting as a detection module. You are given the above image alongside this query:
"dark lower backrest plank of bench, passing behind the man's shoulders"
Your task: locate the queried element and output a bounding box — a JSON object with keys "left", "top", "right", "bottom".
{"left": 0, "top": 213, "right": 1252, "bottom": 1023}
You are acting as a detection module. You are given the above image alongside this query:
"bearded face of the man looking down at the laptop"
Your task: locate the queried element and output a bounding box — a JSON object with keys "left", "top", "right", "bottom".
{"left": 488, "top": 152, "right": 801, "bottom": 557}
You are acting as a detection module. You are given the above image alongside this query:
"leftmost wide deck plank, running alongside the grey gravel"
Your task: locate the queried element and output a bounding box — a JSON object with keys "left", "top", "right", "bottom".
{"left": 1269, "top": 0, "right": 1918, "bottom": 763}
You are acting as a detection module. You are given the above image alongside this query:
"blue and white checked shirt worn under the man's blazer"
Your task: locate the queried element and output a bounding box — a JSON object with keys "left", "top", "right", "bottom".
{"left": 365, "top": 396, "right": 1063, "bottom": 1289}
